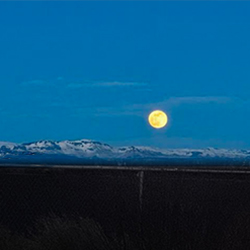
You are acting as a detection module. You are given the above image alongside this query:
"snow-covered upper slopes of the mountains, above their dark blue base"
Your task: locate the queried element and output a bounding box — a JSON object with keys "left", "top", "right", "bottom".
{"left": 0, "top": 139, "right": 250, "bottom": 159}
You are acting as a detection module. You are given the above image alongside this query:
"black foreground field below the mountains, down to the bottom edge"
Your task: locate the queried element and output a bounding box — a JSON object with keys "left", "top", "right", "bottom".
{"left": 0, "top": 166, "right": 250, "bottom": 250}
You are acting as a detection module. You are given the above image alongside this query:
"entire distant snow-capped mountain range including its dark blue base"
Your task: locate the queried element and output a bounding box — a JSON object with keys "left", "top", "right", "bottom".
{"left": 0, "top": 139, "right": 250, "bottom": 166}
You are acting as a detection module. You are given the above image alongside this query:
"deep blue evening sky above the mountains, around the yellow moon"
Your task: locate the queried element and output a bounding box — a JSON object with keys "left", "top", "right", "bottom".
{"left": 0, "top": 1, "right": 250, "bottom": 148}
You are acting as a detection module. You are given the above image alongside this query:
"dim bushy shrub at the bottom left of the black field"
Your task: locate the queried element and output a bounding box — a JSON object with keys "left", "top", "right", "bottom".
{"left": 29, "top": 216, "right": 139, "bottom": 250}
